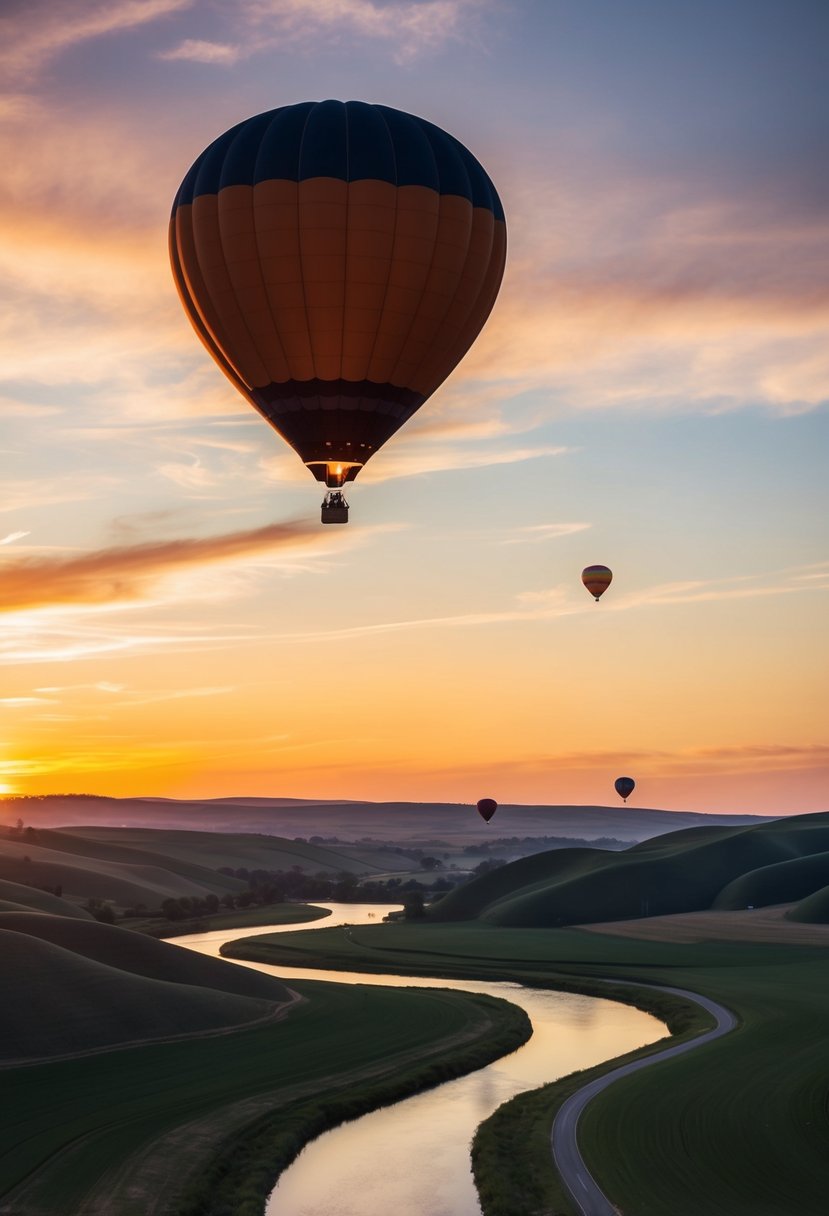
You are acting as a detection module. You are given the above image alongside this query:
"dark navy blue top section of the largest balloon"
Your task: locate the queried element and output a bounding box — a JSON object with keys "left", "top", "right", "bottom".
{"left": 173, "top": 101, "right": 504, "bottom": 220}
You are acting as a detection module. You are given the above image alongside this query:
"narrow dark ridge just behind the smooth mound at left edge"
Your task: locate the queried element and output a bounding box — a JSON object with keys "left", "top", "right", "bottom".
{"left": 0, "top": 912, "right": 288, "bottom": 1001}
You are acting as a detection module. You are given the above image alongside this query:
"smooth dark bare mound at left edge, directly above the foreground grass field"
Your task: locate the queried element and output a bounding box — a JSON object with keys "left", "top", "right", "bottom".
{"left": 0, "top": 929, "right": 286, "bottom": 1063}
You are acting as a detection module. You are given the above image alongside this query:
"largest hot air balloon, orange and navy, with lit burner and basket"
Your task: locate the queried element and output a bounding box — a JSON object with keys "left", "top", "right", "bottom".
{"left": 170, "top": 101, "right": 507, "bottom": 523}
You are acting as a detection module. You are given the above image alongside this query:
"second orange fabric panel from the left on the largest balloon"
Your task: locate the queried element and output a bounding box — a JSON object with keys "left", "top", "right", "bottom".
{"left": 192, "top": 195, "right": 270, "bottom": 385}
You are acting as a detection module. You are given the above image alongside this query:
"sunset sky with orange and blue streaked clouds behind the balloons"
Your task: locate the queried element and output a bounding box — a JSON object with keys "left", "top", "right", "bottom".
{"left": 0, "top": 0, "right": 829, "bottom": 815}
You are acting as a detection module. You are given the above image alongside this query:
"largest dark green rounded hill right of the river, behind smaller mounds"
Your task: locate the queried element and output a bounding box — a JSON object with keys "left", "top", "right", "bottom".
{"left": 429, "top": 814, "right": 829, "bottom": 928}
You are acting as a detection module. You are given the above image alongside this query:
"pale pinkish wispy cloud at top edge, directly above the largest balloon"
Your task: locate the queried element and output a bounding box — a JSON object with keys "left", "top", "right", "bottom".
{"left": 159, "top": 0, "right": 491, "bottom": 64}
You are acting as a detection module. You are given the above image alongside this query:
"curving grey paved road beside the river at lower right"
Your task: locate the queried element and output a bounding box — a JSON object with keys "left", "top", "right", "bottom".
{"left": 551, "top": 984, "right": 737, "bottom": 1216}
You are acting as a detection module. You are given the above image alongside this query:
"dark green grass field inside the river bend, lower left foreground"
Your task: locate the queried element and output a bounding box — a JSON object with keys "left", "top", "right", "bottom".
{"left": 0, "top": 983, "right": 529, "bottom": 1216}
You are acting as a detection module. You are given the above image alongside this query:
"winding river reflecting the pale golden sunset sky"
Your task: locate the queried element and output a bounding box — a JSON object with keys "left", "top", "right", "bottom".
{"left": 174, "top": 903, "right": 666, "bottom": 1216}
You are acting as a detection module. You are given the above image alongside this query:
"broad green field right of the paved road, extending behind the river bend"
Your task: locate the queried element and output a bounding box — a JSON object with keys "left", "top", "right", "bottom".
{"left": 233, "top": 923, "right": 829, "bottom": 1216}
